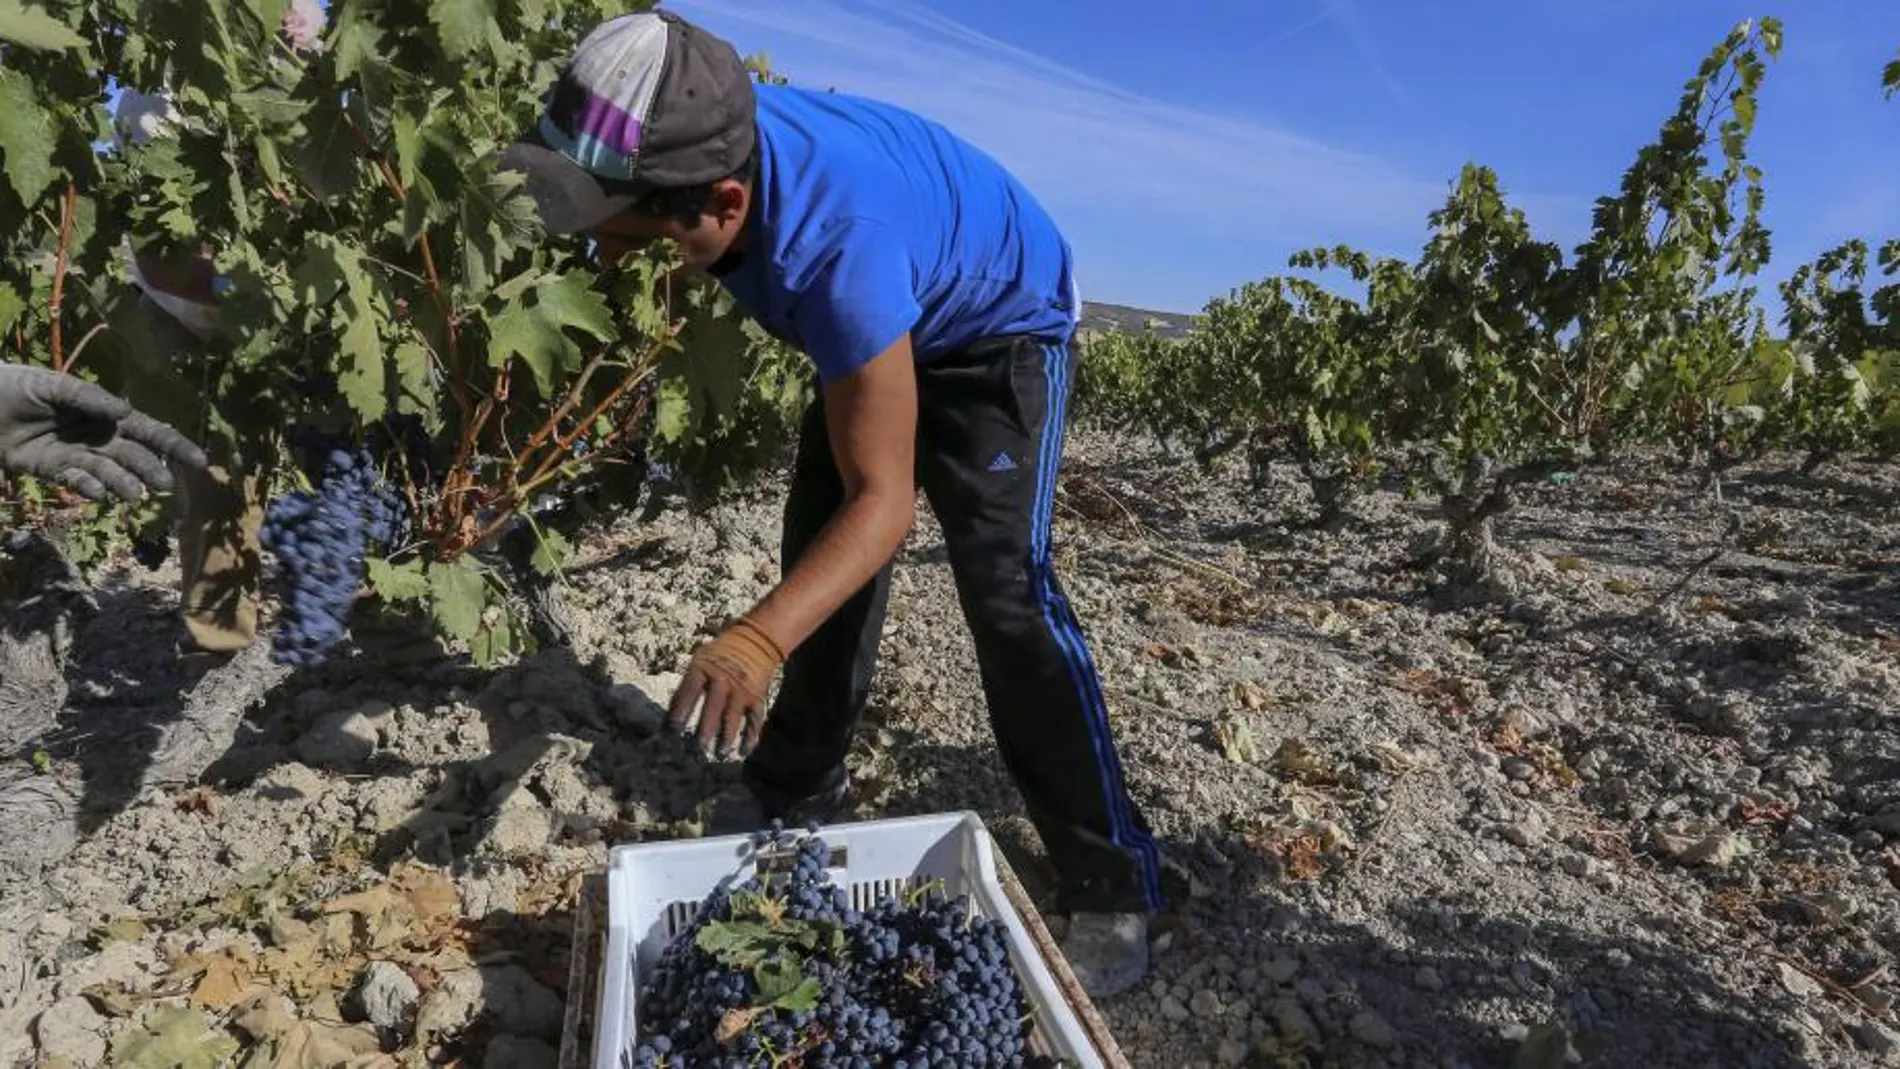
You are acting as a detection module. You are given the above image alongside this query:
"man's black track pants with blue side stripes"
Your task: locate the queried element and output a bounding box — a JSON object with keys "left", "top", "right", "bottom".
{"left": 747, "top": 338, "right": 1161, "bottom": 911}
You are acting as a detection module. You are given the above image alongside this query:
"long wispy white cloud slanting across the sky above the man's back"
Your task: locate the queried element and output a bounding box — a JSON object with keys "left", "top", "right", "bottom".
{"left": 667, "top": 0, "right": 1474, "bottom": 249}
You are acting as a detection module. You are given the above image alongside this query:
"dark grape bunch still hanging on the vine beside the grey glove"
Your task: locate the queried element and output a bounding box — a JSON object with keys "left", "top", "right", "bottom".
{"left": 260, "top": 446, "right": 407, "bottom": 665}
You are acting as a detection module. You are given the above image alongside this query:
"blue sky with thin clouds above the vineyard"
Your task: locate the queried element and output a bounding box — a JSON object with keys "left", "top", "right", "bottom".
{"left": 665, "top": 0, "right": 1900, "bottom": 311}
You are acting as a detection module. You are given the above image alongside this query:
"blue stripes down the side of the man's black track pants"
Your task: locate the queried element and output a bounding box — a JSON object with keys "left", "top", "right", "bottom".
{"left": 1030, "top": 346, "right": 1161, "bottom": 910}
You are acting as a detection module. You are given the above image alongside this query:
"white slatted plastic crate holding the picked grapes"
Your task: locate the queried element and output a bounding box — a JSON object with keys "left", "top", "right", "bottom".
{"left": 593, "top": 813, "right": 1106, "bottom": 1069}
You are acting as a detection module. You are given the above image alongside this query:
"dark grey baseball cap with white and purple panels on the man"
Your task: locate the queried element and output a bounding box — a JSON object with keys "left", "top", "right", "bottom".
{"left": 500, "top": 11, "right": 758, "bottom": 234}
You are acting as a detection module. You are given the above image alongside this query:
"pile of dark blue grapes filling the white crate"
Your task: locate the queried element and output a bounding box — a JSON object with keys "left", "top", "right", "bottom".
{"left": 629, "top": 824, "right": 1055, "bottom": 1069}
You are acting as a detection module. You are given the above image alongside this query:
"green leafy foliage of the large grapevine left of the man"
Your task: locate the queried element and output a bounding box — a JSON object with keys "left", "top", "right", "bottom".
{"left": 0, "top": 0, "right": 804, "bottom": 653}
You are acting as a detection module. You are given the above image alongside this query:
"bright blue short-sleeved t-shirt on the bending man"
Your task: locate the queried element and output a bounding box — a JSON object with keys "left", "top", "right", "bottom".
{"left": 720, "top": 85, "right": 1079, "bottom": 384}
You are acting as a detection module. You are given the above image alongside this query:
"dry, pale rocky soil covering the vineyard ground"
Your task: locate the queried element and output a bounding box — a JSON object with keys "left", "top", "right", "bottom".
{"left": 0, "top": 435, "right": 1900, "bottom": 1069}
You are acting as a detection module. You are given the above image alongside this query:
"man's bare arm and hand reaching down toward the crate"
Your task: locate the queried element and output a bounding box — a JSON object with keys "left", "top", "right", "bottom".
{"left": 667, "top": 332, "right": 918, "bottom": 750}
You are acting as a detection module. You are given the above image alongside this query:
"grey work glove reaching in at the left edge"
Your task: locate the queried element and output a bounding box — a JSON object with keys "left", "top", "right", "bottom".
{"left": 0, "top": 365, "right": 207, "bottom": 501}
